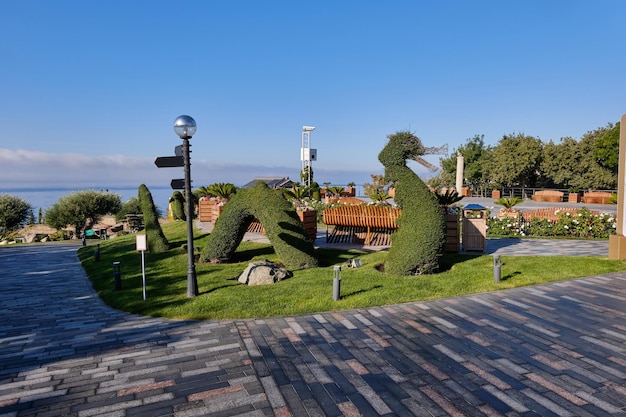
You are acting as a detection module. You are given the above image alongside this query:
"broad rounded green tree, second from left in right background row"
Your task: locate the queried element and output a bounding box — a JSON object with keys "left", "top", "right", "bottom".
{"left": 483, "top": 133, "right": 542, "bottom": 187}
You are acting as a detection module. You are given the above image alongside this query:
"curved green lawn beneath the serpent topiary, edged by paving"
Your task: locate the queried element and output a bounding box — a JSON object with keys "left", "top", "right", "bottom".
{"left": 79, "top": 222, "right": 626, "bottom": 319}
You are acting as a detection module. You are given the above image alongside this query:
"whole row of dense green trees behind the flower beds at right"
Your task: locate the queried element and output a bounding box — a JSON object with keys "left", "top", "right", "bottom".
{"left": 428, "top": 123, "right": 619, "bottom": 194}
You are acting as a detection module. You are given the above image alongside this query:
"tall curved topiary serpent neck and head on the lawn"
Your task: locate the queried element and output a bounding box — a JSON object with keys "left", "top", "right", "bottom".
{"left": 378, "top": 132, "right": 446, "bottom": 275}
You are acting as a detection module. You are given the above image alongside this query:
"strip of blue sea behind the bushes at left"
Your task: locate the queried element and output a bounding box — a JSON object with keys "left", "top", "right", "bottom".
{"left": 0, "top": 186, "right": 174, "bottom": 216}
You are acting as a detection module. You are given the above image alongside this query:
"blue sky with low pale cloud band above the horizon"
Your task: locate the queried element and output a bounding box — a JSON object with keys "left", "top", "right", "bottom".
{"left": 0, "top": 0, "right": 626, "bottom": 191}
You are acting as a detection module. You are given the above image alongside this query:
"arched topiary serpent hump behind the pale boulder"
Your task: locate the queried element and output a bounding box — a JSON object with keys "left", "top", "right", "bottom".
{"left": 200, "top": 182, "right": 318, "bottom": 269}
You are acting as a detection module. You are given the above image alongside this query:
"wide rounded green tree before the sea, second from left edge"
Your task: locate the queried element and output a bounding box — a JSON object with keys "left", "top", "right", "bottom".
{"left": 44, "top": 190, "right": 122, "bottom": 234}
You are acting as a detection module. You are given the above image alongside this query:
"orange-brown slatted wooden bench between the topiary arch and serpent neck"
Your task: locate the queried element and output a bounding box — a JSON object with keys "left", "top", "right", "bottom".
{"left": 322, "top": 205, "right": 402, "bottom": 246}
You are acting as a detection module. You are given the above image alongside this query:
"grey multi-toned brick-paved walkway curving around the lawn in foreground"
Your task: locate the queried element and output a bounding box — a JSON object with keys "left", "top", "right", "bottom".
{"left": 0, "top": 244, "right": 626, "bottom": 417}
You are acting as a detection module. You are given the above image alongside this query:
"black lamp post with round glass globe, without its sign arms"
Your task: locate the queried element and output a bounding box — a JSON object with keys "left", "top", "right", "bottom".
{"left": 174, "top": 116, "right": 198, "bottom": 297}
